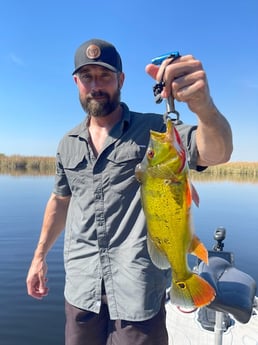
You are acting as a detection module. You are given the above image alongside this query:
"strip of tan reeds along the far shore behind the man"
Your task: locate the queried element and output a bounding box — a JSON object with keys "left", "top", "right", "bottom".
{"left": 0, "top": 153, "right": 258, "bottom": 183}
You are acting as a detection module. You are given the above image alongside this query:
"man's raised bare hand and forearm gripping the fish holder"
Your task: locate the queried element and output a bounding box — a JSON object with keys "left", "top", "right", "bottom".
{"left": 145, "top": 55, "right": 233, "bottom": 166}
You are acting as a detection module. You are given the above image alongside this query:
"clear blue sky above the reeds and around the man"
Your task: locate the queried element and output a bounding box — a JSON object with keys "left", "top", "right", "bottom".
{"left": 0, "top": 0, "right": 258, "bottom": 161}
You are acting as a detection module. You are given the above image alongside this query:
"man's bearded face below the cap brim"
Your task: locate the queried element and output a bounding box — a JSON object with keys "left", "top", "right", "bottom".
{"left": 74, "top": 65, "right": 124, "bottom": 117}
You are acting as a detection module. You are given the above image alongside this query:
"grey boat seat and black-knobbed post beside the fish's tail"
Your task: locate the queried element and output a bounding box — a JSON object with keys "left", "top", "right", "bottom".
{"left": 198, "top": 227, "right": 256, "bottom": 345}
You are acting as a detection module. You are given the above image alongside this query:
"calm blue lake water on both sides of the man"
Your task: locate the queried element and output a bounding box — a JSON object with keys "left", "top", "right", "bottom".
{"left": 0, "top": 175, "right": 258, "bottom": 345}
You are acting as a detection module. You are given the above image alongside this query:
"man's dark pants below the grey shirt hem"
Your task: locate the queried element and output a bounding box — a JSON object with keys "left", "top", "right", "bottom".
{"left": 65, "top": 296, "right": 168, "bottom": 345}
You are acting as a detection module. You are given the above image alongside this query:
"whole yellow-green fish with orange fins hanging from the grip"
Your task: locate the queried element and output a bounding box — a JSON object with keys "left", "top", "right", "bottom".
{"left": 135, "top": 119, "right": 215, "bottom": 308}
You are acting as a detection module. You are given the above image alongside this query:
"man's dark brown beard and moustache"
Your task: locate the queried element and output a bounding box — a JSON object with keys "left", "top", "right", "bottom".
{"left": 80, "top": 88, "right": 121, "bottom": 117}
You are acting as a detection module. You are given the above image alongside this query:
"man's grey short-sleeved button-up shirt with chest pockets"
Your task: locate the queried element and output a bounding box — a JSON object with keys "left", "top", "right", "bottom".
{"left": 54, "top": 103, "right": 197, "bottom": 321}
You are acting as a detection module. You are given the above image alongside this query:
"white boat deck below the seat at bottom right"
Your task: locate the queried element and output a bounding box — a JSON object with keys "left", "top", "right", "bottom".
{"left": 166, "top": 297, "right": 258, "bottom": 345}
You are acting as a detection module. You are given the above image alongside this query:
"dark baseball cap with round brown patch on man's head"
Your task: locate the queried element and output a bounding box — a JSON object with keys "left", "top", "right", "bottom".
{"left": 73, "top": 38, "right": 122, "bottom": 74}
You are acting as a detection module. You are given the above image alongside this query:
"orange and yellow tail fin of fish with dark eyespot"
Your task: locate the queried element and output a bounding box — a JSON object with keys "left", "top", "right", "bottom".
{"left": 170, "top": 273, "right": 216, "bottom": 308}
